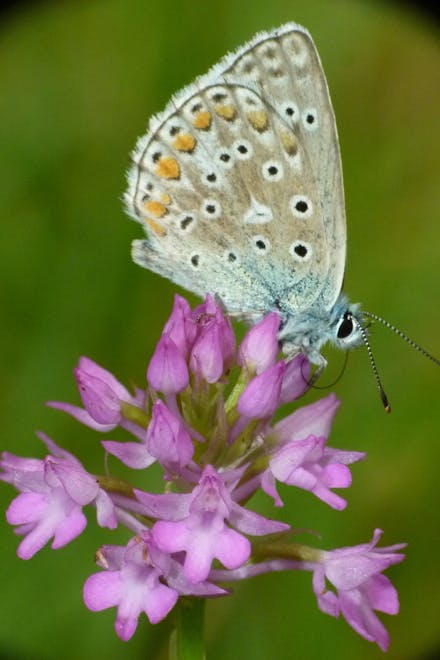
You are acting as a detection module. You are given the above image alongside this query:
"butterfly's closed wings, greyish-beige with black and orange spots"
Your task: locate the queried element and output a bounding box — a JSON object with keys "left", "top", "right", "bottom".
{"left": 126, "top": 24, "right": 346, "bottom": 314}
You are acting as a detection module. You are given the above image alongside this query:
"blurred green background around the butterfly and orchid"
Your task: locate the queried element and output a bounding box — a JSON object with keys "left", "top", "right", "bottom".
{"left": 0, "top": 0, "right": 440, "bottom": 660}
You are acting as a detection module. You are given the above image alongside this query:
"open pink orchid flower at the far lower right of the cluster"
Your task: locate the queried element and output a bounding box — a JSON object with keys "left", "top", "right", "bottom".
{"left": 313, "top": 529, "right": 405, "bottom": 651}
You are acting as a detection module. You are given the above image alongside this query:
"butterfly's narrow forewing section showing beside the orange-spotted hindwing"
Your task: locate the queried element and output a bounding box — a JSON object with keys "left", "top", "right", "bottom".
{"left": 226, "top": 24, "right": 346, "bottom": 309}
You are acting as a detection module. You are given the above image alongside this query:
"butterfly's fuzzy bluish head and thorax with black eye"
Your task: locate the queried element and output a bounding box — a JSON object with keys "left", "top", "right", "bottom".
{"left": 279, "top": 294, "right": 365, "bottom": 365}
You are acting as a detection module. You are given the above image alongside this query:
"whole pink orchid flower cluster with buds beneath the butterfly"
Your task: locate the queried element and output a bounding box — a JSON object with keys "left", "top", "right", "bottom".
{"left": 0, "top": 296, "right": 404, "bottom": 650}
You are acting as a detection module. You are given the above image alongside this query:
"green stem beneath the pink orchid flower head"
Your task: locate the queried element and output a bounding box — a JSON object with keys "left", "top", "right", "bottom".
{"left": 170, "top": 598, "right": 205, "bottom": 660}
